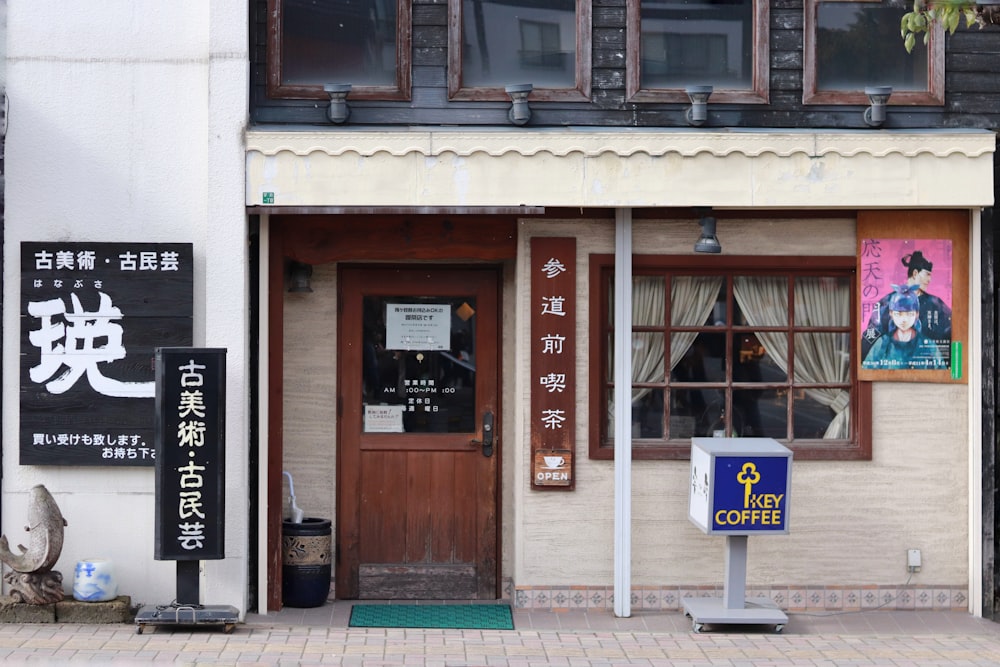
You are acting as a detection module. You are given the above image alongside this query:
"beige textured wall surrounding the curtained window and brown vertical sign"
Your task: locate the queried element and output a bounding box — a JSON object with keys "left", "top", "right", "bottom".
{"left": 508, "top": 219, "right": 969, "bottom": 588}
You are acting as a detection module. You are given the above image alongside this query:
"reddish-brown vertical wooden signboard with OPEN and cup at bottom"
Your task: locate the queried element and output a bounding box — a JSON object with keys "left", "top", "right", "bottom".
{"left": 531, "top": 237, "right": 576, "bottom": 490}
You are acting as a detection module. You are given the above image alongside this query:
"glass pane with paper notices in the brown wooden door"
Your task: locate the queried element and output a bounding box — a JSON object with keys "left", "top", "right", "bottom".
{"left": 361, "top": 296, "right": 476, "bottom": 433}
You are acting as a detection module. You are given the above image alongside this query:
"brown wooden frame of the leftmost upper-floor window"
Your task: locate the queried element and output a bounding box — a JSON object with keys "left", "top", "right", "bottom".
{"left": 267, "top": 0, "right": 413, "bottom": 101}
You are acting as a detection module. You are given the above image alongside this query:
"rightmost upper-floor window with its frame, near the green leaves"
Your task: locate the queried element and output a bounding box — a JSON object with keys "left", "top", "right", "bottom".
{"left": 802, "top": 0, "right": 944, "bottom": 105}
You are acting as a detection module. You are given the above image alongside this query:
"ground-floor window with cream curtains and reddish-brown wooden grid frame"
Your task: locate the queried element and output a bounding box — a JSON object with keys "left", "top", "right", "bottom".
{"left": 591, "top": 256, "right": 871, "bottom": 459}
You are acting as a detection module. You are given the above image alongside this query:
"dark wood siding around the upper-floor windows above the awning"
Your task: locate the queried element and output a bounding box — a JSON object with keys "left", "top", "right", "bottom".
{"left": 250, "top": 0, "right": 1000, "bottom": 129}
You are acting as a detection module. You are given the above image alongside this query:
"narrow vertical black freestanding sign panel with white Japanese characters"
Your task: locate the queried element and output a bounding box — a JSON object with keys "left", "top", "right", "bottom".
{"left": 154, "top": 347, "right": 226, "bottom": 560}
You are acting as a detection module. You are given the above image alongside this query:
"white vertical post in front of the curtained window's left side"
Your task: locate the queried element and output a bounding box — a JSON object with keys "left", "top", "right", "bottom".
{"left": 613, "top": 208, "right": 632, "bottom": 618}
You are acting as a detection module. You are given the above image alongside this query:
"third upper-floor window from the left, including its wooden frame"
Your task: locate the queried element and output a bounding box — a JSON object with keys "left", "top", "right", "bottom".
{"left": 627, "top": 0, "right": 769, "bottom": 103}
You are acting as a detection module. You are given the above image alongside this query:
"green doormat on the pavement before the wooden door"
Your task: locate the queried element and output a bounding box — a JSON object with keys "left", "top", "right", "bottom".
{"left": 348, "top": 604, "right": 514, "bottom": 630}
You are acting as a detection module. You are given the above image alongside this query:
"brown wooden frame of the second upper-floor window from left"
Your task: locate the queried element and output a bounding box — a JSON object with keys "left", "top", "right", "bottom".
{"left": 448, "top": 0, "right": 592, "bottom": 102}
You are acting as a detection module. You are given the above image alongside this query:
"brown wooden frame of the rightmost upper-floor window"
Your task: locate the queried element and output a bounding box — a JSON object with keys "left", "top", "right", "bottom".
{"left": 802, "top": 0, "right": 945, "bottom": 106}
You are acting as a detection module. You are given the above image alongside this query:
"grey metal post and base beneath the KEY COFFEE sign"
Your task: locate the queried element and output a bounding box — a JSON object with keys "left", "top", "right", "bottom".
{"left": 683, "top": 535, "right": 788, "bottom": 632}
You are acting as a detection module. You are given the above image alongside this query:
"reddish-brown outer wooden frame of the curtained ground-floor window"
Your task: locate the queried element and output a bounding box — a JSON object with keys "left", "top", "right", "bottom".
{"left": 589, "top": 254, "right": 872, "bottom": 461}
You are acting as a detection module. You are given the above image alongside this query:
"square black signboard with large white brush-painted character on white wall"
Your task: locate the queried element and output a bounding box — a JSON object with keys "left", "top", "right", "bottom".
{"left": 20, "top": 241, "right": 194, "bottom": 466}
